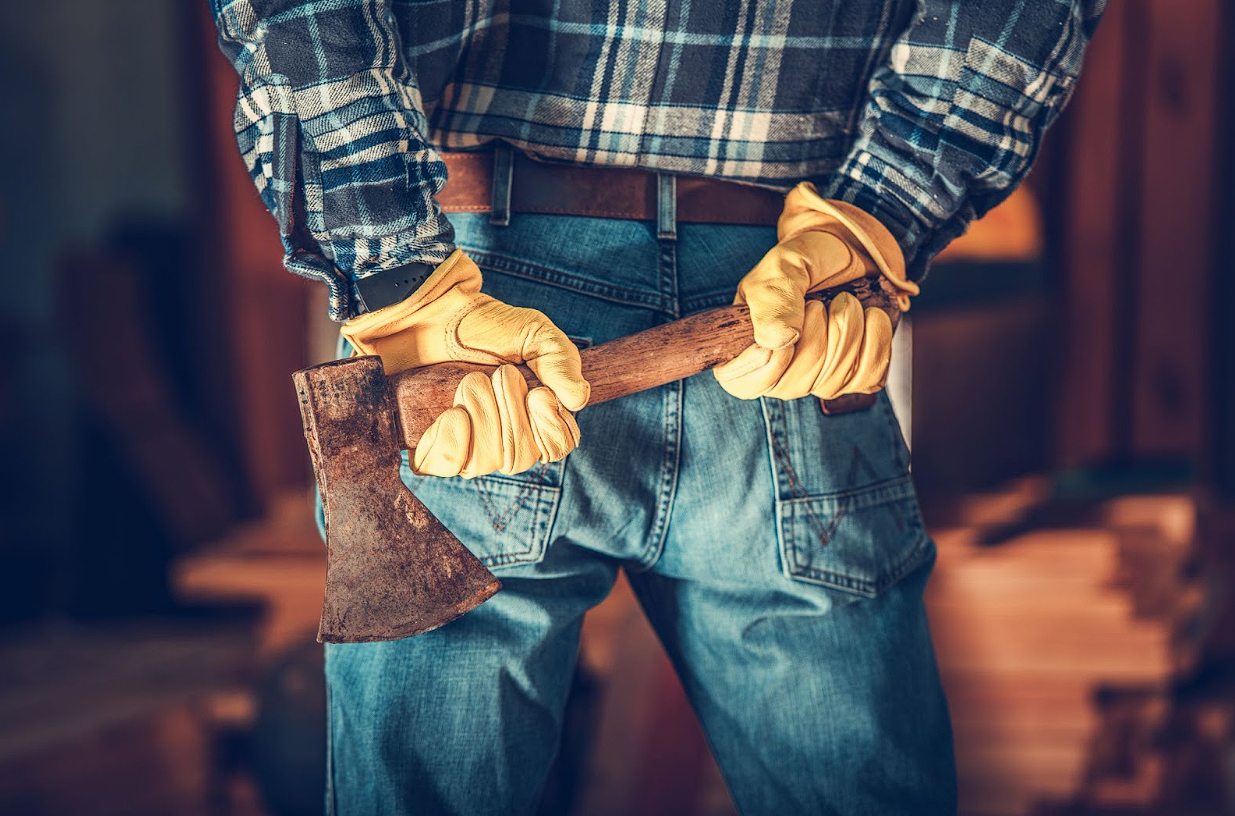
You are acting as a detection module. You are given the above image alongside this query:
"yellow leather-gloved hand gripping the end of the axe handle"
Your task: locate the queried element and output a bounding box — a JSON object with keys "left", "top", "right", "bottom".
{"left": 713, "top": 181, "right": 918, "bottom": 400}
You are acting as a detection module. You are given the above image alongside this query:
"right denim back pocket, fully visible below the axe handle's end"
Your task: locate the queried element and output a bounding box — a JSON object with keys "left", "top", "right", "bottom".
{"left": 764, "top": 395, "right": 934, "bottom": 597}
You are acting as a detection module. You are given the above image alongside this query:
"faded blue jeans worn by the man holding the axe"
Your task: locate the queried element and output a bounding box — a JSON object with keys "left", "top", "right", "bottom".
{"left": 326, "top": 207, "right": 956, "bottom": 816}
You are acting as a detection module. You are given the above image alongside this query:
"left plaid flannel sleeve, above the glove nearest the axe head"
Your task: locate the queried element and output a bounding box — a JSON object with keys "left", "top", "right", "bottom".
{"left": 211, "top": 0, "right": 454, "bottom": 321}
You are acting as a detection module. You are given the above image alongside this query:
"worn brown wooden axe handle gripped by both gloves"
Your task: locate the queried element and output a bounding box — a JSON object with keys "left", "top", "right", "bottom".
{"left": 390, "top": 277, "right": 900, "bottom": 449}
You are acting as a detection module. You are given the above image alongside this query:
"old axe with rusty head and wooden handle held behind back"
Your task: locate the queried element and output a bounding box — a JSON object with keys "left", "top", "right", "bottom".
{"left": 293, "top": 277, "right": 900, "bottom": 643}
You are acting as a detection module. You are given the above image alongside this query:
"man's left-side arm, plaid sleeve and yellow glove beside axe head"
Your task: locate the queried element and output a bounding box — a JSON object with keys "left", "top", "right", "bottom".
{"left": 211, "top": 0, "right": 588, "bottom": 477}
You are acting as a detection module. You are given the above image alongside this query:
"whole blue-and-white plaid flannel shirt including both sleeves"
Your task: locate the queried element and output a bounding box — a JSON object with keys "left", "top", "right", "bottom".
{"left": 211, "top": 0, "right": 1105, "bottom": 320}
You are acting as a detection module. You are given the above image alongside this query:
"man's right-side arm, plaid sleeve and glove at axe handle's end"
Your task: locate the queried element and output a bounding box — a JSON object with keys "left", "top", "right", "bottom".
{"left": 714, "top": 0, "right": 1105, "bottom": 399}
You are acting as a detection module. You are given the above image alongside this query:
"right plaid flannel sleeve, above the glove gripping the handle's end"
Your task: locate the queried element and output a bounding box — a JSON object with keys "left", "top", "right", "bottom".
{"left": 820, "top": 0, "right": 1105, "bottom": 280}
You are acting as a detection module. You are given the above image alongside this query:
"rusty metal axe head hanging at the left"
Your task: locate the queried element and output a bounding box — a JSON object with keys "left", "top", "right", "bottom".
{"left": 293, "top": 357, "right": 501, "bottom": 643}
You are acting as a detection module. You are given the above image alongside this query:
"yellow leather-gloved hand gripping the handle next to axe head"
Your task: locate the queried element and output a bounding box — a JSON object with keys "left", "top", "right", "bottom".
{"left": 341, "top": 249, "right": 590, "bottom": 478}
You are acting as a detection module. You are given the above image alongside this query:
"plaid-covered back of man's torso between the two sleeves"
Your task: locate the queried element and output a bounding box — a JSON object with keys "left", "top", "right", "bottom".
{"left": 394, "top": 0, "right": 913, "bottom": 185}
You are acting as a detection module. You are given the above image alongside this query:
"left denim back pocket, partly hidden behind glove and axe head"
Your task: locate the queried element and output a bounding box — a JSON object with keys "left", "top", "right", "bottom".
{"left": 400, "top": 456, "right": 562, "bottom": 569}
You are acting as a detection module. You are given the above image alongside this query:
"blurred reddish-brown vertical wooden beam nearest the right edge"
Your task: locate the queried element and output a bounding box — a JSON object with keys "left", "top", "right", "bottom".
{"left": 1131, "top": 0, "right": 1221, "bottom": 457}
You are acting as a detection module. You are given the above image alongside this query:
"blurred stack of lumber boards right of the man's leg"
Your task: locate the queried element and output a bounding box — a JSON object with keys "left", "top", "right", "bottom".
{"left": 927, "top": 485, "right": 1192, "bottom": 816}
